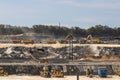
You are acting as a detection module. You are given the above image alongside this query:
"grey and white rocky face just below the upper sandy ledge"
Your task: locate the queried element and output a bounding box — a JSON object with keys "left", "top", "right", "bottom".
{"left": 0, "top": 46, "right": 120, "bottom": 60}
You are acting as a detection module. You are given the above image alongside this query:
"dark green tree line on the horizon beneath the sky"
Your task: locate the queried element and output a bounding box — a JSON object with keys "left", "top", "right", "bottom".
{"left": 0, "top": 24, "right": 120, "bottom": 38}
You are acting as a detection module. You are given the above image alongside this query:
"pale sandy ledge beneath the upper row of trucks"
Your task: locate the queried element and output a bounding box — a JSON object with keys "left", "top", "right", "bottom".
{"left": 0, "top": 43, "right": 120, "bottom": 48}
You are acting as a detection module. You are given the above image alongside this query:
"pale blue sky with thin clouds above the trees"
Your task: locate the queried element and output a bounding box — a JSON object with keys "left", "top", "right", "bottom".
{"left": 0, "top": 0, "right": 120, "bottom": 28}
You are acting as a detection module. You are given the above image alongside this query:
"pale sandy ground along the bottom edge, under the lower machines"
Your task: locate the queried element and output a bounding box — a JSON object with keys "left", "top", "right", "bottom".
{"left": 0, "top": 75, "right": 120, "bottom": 80}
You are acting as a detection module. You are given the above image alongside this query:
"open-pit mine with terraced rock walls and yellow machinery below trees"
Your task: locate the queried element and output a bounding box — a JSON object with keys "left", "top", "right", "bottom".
{"left": 0, "top": 34, "right": 120, "bottom": 80}
